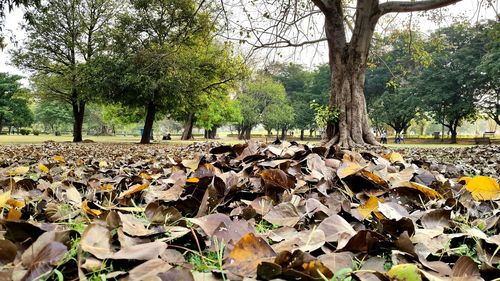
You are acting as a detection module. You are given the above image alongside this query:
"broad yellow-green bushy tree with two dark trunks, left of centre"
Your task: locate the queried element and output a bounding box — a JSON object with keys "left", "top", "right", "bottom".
{"left": 98, "top": 0, "right": 244, "bottom": 143}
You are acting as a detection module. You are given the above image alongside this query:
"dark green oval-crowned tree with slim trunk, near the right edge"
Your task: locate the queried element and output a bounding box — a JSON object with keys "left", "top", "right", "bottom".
{"left": 414, "top": 24, "right": 487, "bottom": 143}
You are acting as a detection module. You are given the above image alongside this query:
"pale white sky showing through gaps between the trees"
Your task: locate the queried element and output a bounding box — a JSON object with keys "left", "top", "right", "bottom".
{"left": 0, "top": 0, "right": 500, "bottom": 80}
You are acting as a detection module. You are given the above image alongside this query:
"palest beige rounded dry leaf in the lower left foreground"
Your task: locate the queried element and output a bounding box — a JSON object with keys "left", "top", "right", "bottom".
{"left": 80, "top": 223, "right": 113, "bottom": 259}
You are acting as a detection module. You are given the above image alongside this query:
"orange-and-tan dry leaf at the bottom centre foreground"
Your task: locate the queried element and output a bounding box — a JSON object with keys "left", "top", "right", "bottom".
{"left": 224, "top": 233, "right": 276, "bottom": 277}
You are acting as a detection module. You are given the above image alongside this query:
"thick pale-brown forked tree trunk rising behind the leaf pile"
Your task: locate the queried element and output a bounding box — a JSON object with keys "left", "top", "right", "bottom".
{"left": 315, "top": 1, "right": 380, "bottom": 147}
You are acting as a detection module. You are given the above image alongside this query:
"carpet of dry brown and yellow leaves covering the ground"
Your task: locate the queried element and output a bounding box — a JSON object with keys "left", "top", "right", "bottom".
{"left": 0, "top": 142, "right": 500, "bottom": 281}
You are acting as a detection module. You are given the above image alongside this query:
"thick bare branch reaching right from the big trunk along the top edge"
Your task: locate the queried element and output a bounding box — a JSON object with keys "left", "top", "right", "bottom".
{"left": 379, "top": 0, "right": 462, "bottom": 15}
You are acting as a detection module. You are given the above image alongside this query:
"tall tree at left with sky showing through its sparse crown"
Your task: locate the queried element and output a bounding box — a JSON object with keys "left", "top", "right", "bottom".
{"left": 12, "top": 0, "right": 117, "bottom": 142}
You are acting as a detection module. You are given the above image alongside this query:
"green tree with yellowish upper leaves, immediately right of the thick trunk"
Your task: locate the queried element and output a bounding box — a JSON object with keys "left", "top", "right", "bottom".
{"left": 365, "top": 30, "right": 432, "bottom": 133}
